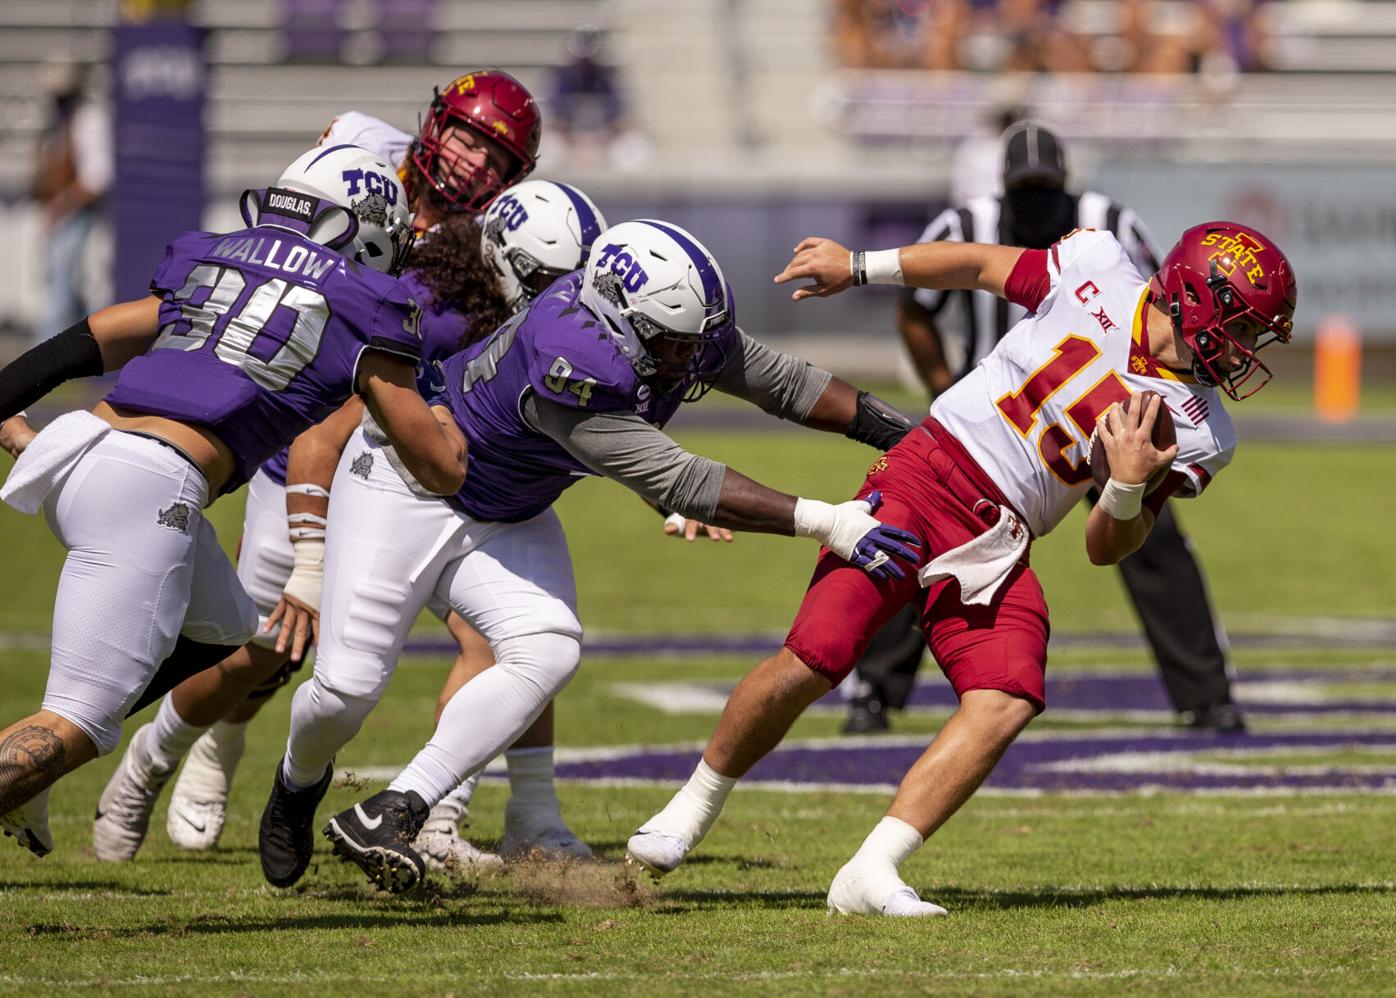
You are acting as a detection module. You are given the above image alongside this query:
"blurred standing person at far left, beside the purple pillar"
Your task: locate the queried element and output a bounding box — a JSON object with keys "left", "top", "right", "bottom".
{"left": 32, "top": 60, "right": 113, "bottom": 339}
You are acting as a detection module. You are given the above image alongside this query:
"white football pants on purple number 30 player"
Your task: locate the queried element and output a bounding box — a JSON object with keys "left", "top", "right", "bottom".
{"left": 17, "top": 430, "right": 257, "bottom": 754}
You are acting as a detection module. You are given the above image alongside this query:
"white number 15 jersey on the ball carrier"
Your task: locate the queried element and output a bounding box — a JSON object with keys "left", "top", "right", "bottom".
{"left": 931, "top": 229, "right": 1235, "bottom": 537}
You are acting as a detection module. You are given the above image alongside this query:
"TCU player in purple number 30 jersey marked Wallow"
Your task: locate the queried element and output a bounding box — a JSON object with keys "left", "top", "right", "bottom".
{"left": 0, "top": 147, "right": 465, "bottom": 856}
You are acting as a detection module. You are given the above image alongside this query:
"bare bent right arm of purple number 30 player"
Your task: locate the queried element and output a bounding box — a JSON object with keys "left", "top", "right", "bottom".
{"left": 359, "top": 350, "right": 466, "bottom": 496}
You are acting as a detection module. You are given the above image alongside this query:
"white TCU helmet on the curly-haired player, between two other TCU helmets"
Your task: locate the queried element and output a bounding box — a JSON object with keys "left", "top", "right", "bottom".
{"left": 480, "top": 180, "right": 606, "bottom": 310}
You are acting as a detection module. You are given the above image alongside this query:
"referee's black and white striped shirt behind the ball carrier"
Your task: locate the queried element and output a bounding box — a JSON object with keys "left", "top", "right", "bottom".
{"left": 912, "top": 191, "right": 1159, "bottom": 380}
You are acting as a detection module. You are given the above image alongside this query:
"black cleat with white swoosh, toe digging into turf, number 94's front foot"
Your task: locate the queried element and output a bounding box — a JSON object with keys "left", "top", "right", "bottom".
{"left": 325, "top": 790, "right": 431, "bottom": 895}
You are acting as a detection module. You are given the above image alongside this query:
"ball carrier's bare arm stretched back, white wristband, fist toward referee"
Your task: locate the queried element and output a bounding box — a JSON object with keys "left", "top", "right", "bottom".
{"left": 775, "top": 237, "right": 1023, "bottom": 301}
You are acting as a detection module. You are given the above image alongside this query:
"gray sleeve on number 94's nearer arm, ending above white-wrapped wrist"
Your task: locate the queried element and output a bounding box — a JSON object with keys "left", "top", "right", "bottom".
{"left": 519, "top": 392, "right": 727, "bottom": 522}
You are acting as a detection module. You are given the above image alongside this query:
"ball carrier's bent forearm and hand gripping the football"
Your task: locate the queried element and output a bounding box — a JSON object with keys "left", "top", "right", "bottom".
{"left": 1086, "top": 394, "right": 1178, "bottom": 565}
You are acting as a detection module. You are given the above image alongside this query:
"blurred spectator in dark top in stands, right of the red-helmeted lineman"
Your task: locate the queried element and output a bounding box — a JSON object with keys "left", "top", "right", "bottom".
{"left": 544, "top": 25, "right": 649, "bottom": 169}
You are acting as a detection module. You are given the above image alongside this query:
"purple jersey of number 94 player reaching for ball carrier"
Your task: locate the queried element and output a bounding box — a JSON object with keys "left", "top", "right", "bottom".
{"left": 433, "top": 272, "right": 731, "bottom": 523}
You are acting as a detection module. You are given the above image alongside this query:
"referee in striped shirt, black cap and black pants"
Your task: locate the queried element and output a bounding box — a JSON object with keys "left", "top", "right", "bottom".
{"left": 845, "top": 121, "right": 1245, "bottom": 733}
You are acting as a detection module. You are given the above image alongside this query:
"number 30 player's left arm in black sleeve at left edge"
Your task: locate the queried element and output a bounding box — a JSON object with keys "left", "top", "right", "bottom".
{"left": 0, "top": 295, "right": 161, "bottom": 422}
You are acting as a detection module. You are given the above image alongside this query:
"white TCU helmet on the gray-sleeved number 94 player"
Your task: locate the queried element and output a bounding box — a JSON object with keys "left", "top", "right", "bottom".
{"left": 581, "top": 219, "right": 736, "bottom": 393}
